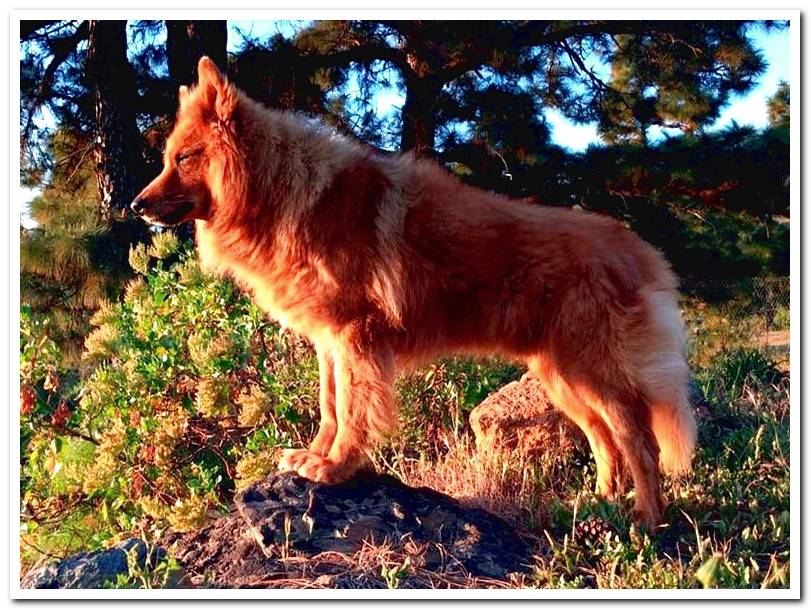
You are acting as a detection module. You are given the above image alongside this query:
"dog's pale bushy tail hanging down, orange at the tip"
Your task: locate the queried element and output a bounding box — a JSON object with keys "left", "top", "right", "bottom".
{"left": 638, "top": 289, "right": 696, "bottom": 474}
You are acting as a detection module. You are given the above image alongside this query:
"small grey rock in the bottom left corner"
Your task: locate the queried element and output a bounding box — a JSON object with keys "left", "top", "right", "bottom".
{"left": 20, "top": 538, "right": 176, "bottom": 589}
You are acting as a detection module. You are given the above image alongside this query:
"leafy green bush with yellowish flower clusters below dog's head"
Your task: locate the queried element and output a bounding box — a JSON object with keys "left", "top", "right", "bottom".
{"left": 20, "top": 233, "right": 318, "bottom": 552}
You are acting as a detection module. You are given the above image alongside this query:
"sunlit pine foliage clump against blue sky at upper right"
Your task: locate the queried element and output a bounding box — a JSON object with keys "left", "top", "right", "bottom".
{"left": 588, "top": 21, "right": 765, "bottom": 145}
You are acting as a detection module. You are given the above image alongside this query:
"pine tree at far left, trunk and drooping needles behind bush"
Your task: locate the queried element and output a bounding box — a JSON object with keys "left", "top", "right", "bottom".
{"left": 20, "top": 21, "right": 190, "bottom": 363}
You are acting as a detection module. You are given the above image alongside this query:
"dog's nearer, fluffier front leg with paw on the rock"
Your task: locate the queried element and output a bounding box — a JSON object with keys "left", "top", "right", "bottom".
{"left": 280, "top": 329, "right": 397, "bottom": 483}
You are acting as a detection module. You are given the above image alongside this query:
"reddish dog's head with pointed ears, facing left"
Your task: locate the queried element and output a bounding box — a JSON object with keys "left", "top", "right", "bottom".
{"left": 130, "top": 57, "right": 239, "bottom": 226}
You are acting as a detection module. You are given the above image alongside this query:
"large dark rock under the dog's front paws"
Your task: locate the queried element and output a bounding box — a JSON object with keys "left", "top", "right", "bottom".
{"left": 163, "top": 473, "right": 532, "bottom": 587}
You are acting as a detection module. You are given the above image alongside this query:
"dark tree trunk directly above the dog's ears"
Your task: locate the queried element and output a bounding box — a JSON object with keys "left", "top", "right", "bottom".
{"left": 166, "top": 21, "right": 228, "bottom": 86}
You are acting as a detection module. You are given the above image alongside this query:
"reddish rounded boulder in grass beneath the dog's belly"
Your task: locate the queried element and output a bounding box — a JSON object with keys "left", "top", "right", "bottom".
{"left": 470, "top": 377, "right": 588, "bottom": 457}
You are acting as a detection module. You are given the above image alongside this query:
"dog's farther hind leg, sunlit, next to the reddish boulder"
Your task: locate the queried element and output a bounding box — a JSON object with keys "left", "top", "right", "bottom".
{"left": 528, "top": 357, "right": 625, "bottom": 500}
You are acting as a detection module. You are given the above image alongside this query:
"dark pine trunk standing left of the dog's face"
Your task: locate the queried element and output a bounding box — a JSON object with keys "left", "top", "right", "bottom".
{"left": 85, "top": 21, "right": 146, "bottom": 221}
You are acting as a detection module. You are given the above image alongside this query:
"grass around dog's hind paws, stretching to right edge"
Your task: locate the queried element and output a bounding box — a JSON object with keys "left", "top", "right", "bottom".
{"left": 382, "top": 342, "right": 790, "bottom": 588}
